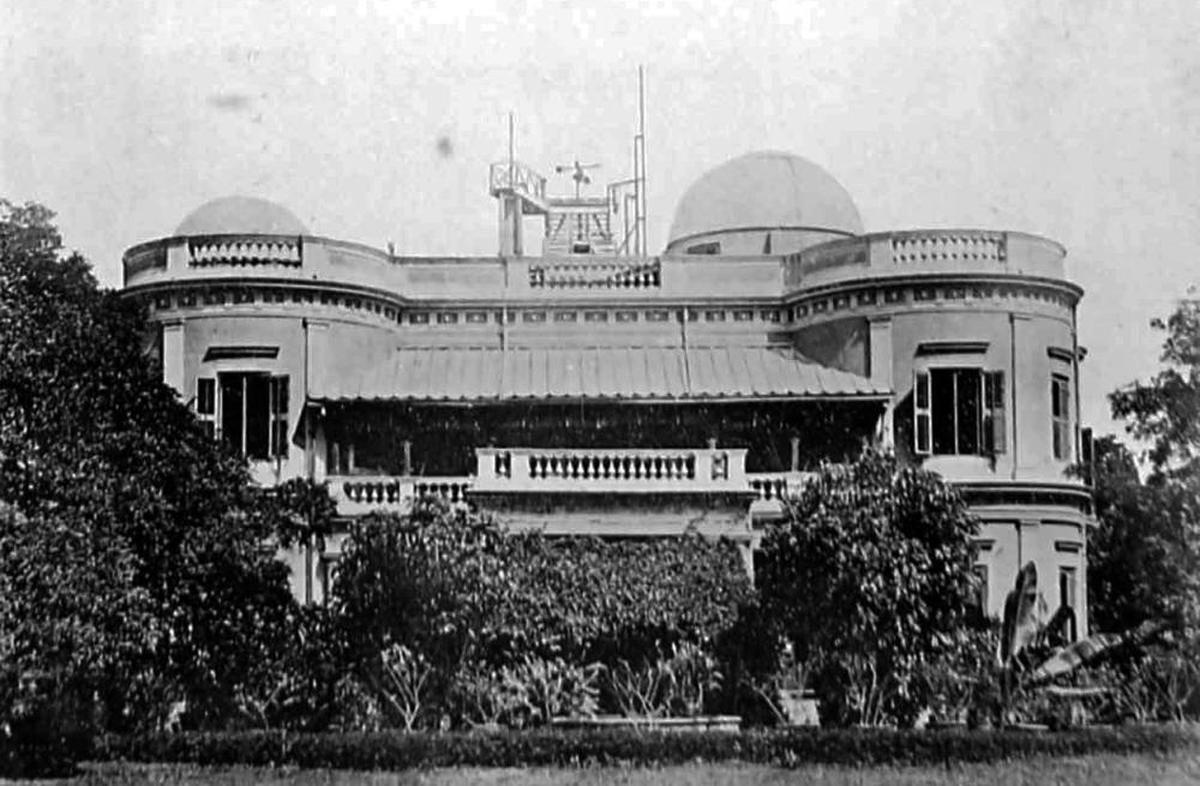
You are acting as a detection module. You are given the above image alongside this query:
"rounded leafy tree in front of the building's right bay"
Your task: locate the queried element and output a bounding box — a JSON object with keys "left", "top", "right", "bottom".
{"left": 757, "top": 452, "right": 978, "bottom": 724}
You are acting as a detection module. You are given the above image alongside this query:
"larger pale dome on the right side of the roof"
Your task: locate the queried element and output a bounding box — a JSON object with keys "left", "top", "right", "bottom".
{"left": 667, "top": 150, "right": 863, "bottom": 246}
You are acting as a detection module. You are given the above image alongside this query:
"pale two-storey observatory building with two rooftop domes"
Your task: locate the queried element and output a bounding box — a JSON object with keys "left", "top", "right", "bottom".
{"left": 124, "top": 145, "right": 1093, "bottom": 634}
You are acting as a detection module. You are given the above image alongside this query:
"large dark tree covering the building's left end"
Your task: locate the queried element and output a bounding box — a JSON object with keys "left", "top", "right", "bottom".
{"left": 0, "top": 199, "right": 293, "bottom": 726}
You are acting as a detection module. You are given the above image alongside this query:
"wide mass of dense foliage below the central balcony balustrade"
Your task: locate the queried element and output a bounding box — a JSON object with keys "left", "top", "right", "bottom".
{"left": 334, "top": 505, "right": 751, "bottom": 665}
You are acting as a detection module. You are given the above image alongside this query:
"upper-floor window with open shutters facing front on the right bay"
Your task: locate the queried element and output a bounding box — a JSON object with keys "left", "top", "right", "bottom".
{"left": 913, "top": 368, "right": 1007, "bottom": 456}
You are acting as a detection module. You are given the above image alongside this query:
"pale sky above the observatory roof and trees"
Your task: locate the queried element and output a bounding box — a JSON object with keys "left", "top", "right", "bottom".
{"left": 0, "top": 0, "right": 1200, "bottom": 441}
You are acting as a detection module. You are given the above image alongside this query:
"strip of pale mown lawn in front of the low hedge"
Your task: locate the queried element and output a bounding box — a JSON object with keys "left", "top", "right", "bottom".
{"left": 35, "top": 751, "right": 1200, "bottom": 786}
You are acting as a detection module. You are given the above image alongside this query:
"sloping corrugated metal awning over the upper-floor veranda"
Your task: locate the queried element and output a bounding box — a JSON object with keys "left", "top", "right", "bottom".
{"left": 311, "top": 346, "right": 890, "bottom": 403}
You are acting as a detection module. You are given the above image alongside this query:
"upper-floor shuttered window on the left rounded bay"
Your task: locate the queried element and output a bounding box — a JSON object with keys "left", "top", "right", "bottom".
{"left": 215, "top": 372, "right": 288, "bottom": 460}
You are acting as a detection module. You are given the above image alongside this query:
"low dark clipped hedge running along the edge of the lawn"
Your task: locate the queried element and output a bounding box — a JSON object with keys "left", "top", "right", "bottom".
{"left": 96, "top": 726, "right": 1200, "bottom": 770}
